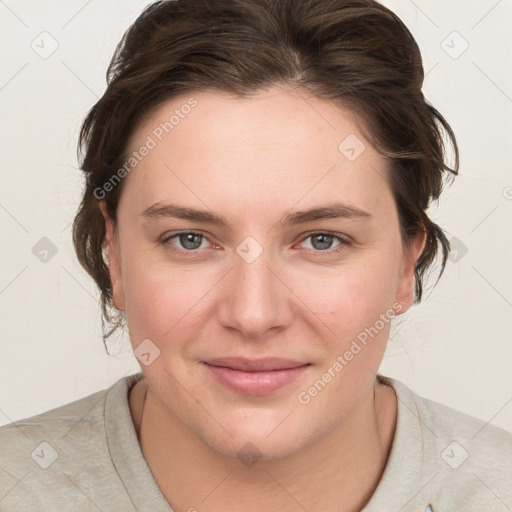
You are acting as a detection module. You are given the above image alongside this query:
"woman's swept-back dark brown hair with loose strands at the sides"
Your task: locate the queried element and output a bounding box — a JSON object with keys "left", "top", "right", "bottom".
{"left": 73, "top": 0, "right": 459, "bottom": 346}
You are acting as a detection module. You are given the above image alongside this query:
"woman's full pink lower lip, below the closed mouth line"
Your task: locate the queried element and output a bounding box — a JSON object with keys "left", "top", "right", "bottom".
{"left": 205, "top": 363, "right": 310, "bottom": 396}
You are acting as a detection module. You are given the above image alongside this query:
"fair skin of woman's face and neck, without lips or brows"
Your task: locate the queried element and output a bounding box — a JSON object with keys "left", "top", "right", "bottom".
{"left": 102, "top": 86, "right": 424, "bottom": 512}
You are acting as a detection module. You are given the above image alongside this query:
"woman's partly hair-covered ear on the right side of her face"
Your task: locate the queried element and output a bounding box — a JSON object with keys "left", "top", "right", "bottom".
{"left": 393, "top": 230, "right": 427, "bottom": 315}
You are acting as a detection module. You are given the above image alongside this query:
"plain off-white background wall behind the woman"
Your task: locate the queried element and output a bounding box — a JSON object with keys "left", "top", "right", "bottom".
{"left": 0, "top": 0, "right": 512, "bottom": 431}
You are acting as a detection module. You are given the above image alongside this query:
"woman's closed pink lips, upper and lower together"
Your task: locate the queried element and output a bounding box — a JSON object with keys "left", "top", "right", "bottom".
{"left": 204, "top": 357, "right": 310, "bottom": 396}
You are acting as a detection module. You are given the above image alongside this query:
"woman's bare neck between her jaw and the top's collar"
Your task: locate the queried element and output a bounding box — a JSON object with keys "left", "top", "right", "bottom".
{"left": 130, "top": 380, "right": 396, "bottom": 512}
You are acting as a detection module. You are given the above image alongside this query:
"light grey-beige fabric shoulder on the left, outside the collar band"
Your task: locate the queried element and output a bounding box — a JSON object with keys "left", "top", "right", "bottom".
{"left": 0, "top": 378, "right": 139, "bottom": 511}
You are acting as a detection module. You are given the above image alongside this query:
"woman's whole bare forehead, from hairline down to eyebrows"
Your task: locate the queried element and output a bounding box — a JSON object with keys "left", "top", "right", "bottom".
{"left": 120, "top": 87, "right": 389, "bottom": 218}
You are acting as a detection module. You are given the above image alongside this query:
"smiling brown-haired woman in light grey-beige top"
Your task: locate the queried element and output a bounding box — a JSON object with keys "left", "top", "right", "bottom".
{"left": 0, "top": 0, "right": 512, "bottom": 512}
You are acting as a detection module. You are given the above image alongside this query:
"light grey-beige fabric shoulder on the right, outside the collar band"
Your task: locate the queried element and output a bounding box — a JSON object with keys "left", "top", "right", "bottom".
{"left": 384, "top": 378, "right": 512, "bottom": 512}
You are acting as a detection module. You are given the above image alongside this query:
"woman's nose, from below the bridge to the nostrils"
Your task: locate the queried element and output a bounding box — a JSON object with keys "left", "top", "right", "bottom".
{"left": 218, "top": 243, "right": 294, "bottom": 340}
